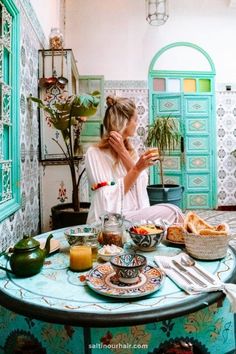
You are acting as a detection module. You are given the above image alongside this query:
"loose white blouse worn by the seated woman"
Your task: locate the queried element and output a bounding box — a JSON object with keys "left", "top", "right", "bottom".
{"left": 85, "top": 146, "right": 150, "bottom": 223}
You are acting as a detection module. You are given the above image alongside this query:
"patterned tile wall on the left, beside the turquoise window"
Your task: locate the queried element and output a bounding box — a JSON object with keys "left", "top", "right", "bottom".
{"left": 0, "top": 0, "right": 45, "bottom": 250}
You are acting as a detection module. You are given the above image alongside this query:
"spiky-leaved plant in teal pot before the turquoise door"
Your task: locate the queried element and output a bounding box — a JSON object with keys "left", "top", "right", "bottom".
{"left": 146, "top": 116, "right": 184, "bottom": 206}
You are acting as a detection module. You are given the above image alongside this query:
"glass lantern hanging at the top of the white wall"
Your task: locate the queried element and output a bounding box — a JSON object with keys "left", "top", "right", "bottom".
{"left": 146, "top": 0, "right": 169, "bottom": 26}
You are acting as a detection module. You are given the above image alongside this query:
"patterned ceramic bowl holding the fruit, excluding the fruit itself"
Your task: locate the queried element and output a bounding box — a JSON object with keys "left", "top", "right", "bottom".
{"left": 128, "top": 225, "right": 165, "bottom": 252}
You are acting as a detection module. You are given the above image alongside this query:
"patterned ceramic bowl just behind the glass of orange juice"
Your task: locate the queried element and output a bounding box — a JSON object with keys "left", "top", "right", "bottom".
{"left": 64, "top": 224, "right": 100, "bottom": 247}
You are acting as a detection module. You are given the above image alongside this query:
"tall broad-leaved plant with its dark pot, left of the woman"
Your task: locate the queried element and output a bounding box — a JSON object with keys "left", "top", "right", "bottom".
{"left": 28, "top": 91, "right": 100, "bottom": 229}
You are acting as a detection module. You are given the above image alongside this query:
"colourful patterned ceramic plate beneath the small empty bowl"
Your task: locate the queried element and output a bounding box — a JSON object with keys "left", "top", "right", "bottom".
{"left": 87, "top": 262, "right": 164, "bottom": 298}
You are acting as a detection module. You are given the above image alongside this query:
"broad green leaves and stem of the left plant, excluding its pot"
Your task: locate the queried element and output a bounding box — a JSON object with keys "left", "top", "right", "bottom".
{"left": 28, "top": 91, "right": 100, "bottom": 211}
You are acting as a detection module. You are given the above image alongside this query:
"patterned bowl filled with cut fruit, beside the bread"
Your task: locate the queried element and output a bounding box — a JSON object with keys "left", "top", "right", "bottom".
{"left": 128, "top": 222, "right": 165, "bottom": 252}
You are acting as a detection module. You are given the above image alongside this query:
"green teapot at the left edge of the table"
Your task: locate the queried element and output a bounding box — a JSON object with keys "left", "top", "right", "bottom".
{"left": 7, "top": 234, "right": 53, "bottom": 277}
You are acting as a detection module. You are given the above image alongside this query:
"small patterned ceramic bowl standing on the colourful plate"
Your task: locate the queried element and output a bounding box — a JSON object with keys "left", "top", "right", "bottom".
{"left": 110, "top": 253, "right": 147, "bottom": 284}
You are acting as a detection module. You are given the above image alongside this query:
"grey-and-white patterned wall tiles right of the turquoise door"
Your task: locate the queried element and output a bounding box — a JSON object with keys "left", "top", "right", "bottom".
{"left": 216, "top": 91, "right": 236, "bottom": 206}
